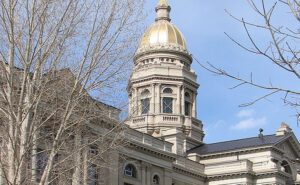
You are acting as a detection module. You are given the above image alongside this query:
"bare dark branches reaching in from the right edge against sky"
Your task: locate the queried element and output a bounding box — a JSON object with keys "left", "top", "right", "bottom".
{"left": 196, "top": 0, "right": 300, "bottom": 120}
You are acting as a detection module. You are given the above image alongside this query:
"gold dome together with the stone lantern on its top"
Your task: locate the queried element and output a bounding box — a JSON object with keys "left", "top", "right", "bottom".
{"left": 135, "top": 0, "right": 192, "bottom": 60}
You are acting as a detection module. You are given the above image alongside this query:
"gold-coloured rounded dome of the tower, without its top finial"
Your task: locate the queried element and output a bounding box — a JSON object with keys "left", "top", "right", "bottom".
{"left": 140, "top": 20, "right": 187, "bottom": 50}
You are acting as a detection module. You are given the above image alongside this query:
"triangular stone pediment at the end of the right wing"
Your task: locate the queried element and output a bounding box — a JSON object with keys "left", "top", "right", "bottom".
{"left": 275, "top": 134, "right": 300, "bottom": 159}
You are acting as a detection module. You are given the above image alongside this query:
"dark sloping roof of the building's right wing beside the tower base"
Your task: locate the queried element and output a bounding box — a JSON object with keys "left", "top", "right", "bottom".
{"left": 187, "top": 135, "right": 287, "bottom": 155}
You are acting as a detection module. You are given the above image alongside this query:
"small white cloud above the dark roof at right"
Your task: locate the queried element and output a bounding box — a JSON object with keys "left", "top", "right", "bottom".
{"left": 231, "top": 117, "right": 267, "bottom": 130}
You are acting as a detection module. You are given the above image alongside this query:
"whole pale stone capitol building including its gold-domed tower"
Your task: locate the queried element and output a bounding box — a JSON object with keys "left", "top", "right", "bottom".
{"left": 0, "top": 0, "right": 300, "bottom": 185}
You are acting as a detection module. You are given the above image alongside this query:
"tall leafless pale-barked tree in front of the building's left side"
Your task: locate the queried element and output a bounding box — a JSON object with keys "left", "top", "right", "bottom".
{"left": 0, "top": 0, "right": 143, "bottom": 185}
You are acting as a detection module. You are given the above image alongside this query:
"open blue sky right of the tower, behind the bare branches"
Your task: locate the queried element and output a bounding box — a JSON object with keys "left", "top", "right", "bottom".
{"left": 145, "top": 0, "right": 300, "bottom": 143}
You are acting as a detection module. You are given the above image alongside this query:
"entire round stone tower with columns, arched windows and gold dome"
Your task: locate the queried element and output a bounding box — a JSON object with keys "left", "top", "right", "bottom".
{"left": 126, "top": 0, "right": 204, "bottom": 155}
